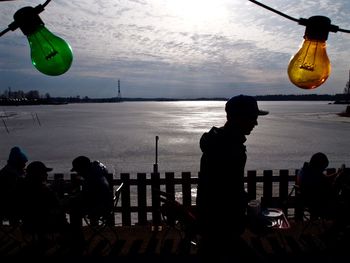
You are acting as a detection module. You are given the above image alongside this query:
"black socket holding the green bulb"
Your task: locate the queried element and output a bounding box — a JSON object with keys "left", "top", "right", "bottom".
{"left": 13, "top": 6, "right": 45, "bottom": 36}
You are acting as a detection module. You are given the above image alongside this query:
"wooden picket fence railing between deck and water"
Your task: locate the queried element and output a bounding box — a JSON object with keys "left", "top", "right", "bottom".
{"left": 51, "top": 168, "right": 335, "bottom": 226}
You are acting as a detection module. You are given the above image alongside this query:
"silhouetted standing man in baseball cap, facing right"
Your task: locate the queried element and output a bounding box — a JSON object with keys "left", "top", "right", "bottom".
{"left": 196, "top": 95, "right": 268, "bottom": 262}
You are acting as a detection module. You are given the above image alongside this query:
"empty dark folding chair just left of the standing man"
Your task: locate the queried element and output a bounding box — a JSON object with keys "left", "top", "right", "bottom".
{"left": 158, "top": 191, "right": 198, "bottom": 252}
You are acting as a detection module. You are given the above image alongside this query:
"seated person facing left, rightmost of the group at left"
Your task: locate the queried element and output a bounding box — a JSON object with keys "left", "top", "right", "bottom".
{"left": 69, "top": 156, "right": 113, "bottom": 229}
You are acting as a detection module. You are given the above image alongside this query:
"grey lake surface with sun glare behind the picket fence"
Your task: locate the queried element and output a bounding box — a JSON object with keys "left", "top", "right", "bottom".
{"left": 0, "top": 101, "right": 350, "bottom": 177}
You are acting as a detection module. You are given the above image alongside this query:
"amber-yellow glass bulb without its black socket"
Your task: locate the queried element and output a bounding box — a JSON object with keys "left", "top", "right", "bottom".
{"left": 288, "top": 38, "right": 331, "bottom": 89}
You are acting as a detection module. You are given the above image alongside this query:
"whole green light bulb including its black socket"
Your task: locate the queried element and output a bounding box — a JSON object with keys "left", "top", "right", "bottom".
{"left": 14, "top": 7, "right": 73, "bottom": 76}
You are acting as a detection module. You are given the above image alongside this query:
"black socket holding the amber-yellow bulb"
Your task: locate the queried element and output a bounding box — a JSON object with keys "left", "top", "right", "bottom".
{"left": 304, "top": 16, "right": 331, "bottom": 41}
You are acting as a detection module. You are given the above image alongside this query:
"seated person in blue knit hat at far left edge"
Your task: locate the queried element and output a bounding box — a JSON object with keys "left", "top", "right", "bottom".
{"left": 0, "top": 146, "right": 28, "bottom": 225}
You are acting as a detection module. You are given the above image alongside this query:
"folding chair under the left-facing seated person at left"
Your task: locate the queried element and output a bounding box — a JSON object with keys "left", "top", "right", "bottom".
{"left": 83, "top": 183, "right": 124, "bottom": 251}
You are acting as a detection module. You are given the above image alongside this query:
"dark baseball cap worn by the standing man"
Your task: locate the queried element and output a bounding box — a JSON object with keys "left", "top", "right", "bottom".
{"left": 225, "top": 95, "right": 269, "bottom": 116}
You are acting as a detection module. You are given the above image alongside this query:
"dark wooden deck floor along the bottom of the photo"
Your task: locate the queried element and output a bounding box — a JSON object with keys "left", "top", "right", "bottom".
{"left": 0, "top": 221, "right": 350, "bottom": 262}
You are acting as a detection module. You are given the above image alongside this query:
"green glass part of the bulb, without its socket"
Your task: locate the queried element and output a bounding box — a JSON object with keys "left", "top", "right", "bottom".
{"left": 27, "top": 25, "right": 73, "bottom": 76}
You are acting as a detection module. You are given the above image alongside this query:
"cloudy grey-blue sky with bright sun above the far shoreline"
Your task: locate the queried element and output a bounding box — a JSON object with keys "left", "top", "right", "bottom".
{"left": 0, "top": 0, "right": 350, "bottom": 98}
